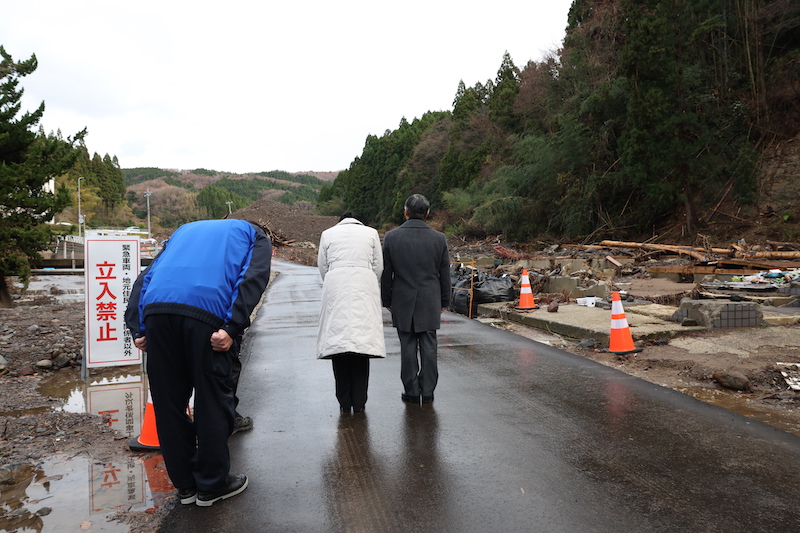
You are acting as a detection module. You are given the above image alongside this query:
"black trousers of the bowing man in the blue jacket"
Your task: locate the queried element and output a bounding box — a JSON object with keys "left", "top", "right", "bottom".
{"left": 145, "top": 314, "right": 236, "bottom": 491}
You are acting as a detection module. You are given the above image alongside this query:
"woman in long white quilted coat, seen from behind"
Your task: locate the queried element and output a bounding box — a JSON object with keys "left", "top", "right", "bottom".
{"left": 317, "top": 211, "right": 386, "bottom": 413}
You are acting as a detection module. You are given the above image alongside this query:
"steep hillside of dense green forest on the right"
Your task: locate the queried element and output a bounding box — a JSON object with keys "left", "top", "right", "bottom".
{"left": 319, "top": 0, "right": 800, "bottom": 245}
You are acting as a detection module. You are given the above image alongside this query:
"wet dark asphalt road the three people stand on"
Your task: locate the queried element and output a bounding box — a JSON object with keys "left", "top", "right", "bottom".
{"left": 161, "top": 263, "right": 800, "bottom": 533}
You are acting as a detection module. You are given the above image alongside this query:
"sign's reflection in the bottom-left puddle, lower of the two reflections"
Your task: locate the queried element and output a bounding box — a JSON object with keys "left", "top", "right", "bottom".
{"left": 89, "top": 457, "right": 145, "bottom": 513}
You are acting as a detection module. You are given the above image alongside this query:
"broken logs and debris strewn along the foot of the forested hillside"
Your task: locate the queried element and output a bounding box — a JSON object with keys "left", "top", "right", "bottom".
{"left": 444, "top": 237, "right": 800, "bottom": 316}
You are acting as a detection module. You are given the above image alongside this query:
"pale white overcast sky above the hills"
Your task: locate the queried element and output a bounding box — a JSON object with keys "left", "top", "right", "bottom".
{"left": 0, "top": 0, "right": 572, "bottom": 173}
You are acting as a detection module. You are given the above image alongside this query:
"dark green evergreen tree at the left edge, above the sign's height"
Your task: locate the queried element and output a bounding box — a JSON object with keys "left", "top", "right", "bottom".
{"left": 0, "top": 46, "right": 86, "bottom": 307}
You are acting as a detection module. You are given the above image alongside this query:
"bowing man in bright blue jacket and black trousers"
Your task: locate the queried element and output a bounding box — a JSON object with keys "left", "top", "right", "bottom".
{"left": 125, "top": 219, "right": 272, "bottom": 507}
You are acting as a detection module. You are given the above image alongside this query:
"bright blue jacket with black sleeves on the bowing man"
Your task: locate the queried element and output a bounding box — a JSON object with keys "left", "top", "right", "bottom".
{"left": 125, "top": 219, "right": 272, "bottom": 338}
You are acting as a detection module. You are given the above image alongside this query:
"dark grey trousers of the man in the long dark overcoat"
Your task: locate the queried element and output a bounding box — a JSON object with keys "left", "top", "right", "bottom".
{"left": 397, "top": 330, "right": 439, "bottom": 396}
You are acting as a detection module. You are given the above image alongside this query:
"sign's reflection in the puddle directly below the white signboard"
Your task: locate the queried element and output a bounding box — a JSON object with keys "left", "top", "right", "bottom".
{"left": 86, "top": 382, "right": 144, "bottom": 437}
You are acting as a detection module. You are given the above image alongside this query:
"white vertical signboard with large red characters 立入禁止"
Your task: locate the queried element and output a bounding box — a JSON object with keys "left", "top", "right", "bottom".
{"left": 83, "top": 235, "right": 142, "bottom": 368}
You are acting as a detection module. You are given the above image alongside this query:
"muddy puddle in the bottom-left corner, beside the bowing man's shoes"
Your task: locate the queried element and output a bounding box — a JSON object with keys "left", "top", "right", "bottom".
{"left": 0, "top": 455, "right": 174, "bottom": 533}
